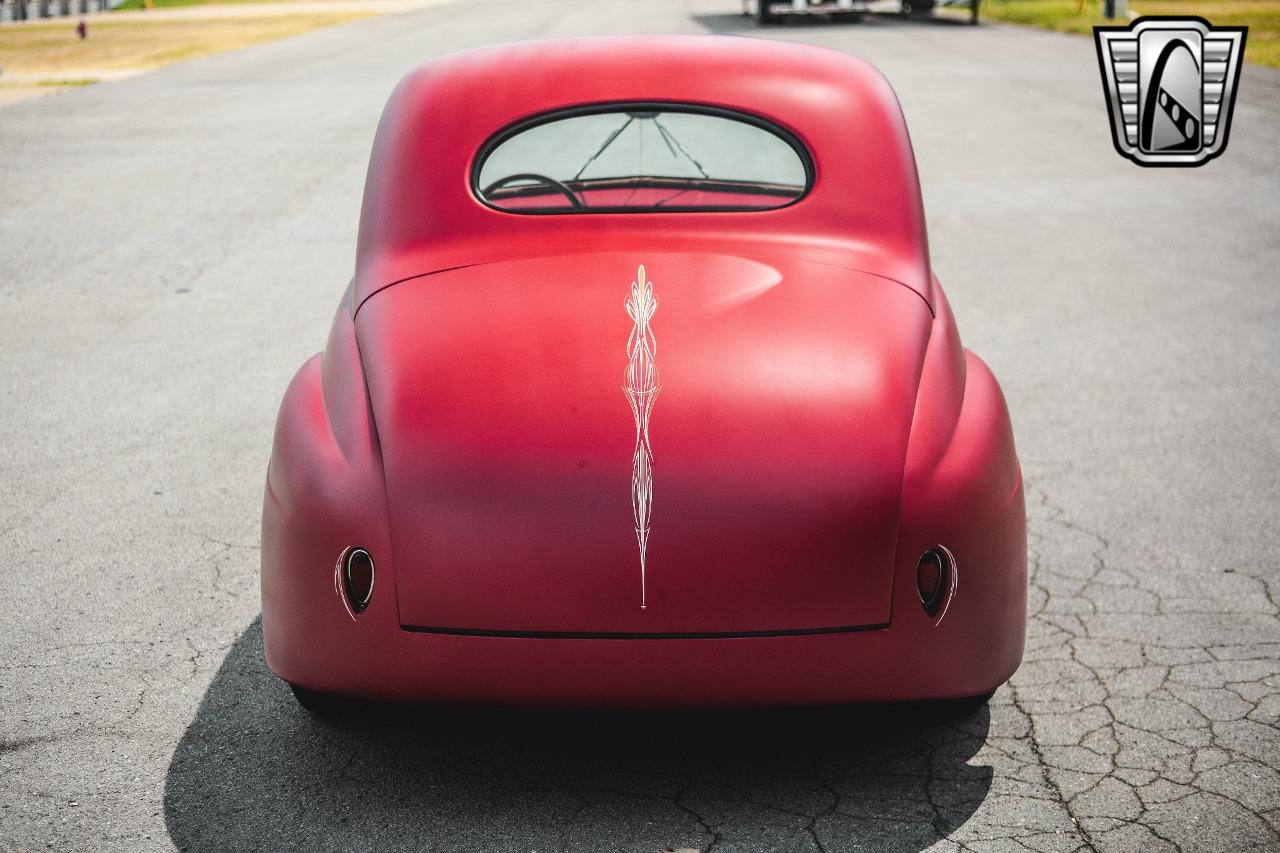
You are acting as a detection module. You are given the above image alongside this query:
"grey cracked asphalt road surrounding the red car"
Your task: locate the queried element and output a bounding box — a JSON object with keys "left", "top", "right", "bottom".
{"left": 0, "top": 0, "right": 1280, "bottom": 853}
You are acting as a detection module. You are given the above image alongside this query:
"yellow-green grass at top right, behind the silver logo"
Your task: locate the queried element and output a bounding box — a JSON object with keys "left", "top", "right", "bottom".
{"left": 982, "top": 0, "right": 1280, "bottom": 68}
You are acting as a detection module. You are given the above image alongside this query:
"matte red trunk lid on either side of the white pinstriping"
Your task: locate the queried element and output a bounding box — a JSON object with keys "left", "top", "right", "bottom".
{"left": 356, "top": 254, "right": 932, "bottom": 634}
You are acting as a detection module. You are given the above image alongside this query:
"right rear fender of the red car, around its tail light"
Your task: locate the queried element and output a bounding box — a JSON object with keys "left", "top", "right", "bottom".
{"left": 893, "top": 279, "right": 1027, "bottom": 694}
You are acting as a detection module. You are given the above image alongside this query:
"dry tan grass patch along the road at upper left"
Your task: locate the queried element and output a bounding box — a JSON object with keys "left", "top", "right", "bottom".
{"left": 0, "top": 12, "right": 367, "bottom": 76}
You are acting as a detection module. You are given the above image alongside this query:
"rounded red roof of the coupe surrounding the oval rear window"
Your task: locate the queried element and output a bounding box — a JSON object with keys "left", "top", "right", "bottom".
{"left": 353, "top": 36, "right": 929, "bottom": 305}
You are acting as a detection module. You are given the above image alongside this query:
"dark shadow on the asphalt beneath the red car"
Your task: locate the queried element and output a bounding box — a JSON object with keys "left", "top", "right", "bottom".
{"left": 164, "top": 620, "right": 992, "bottom": 853}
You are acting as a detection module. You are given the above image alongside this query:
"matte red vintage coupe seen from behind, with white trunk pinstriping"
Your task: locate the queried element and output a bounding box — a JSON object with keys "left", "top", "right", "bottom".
{"left": 262, "top": 36, "right": 1027, "bottom": 707}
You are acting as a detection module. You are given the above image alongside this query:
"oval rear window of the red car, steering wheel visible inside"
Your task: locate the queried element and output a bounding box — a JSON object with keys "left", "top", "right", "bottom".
{"left": 472, "top": 104, "right": 813, "bottom": 214}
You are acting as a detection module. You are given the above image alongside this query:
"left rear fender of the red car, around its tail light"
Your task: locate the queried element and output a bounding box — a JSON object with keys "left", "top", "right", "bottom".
{"left": 262, "top": 289, "right": 399, "bottom": 690}
